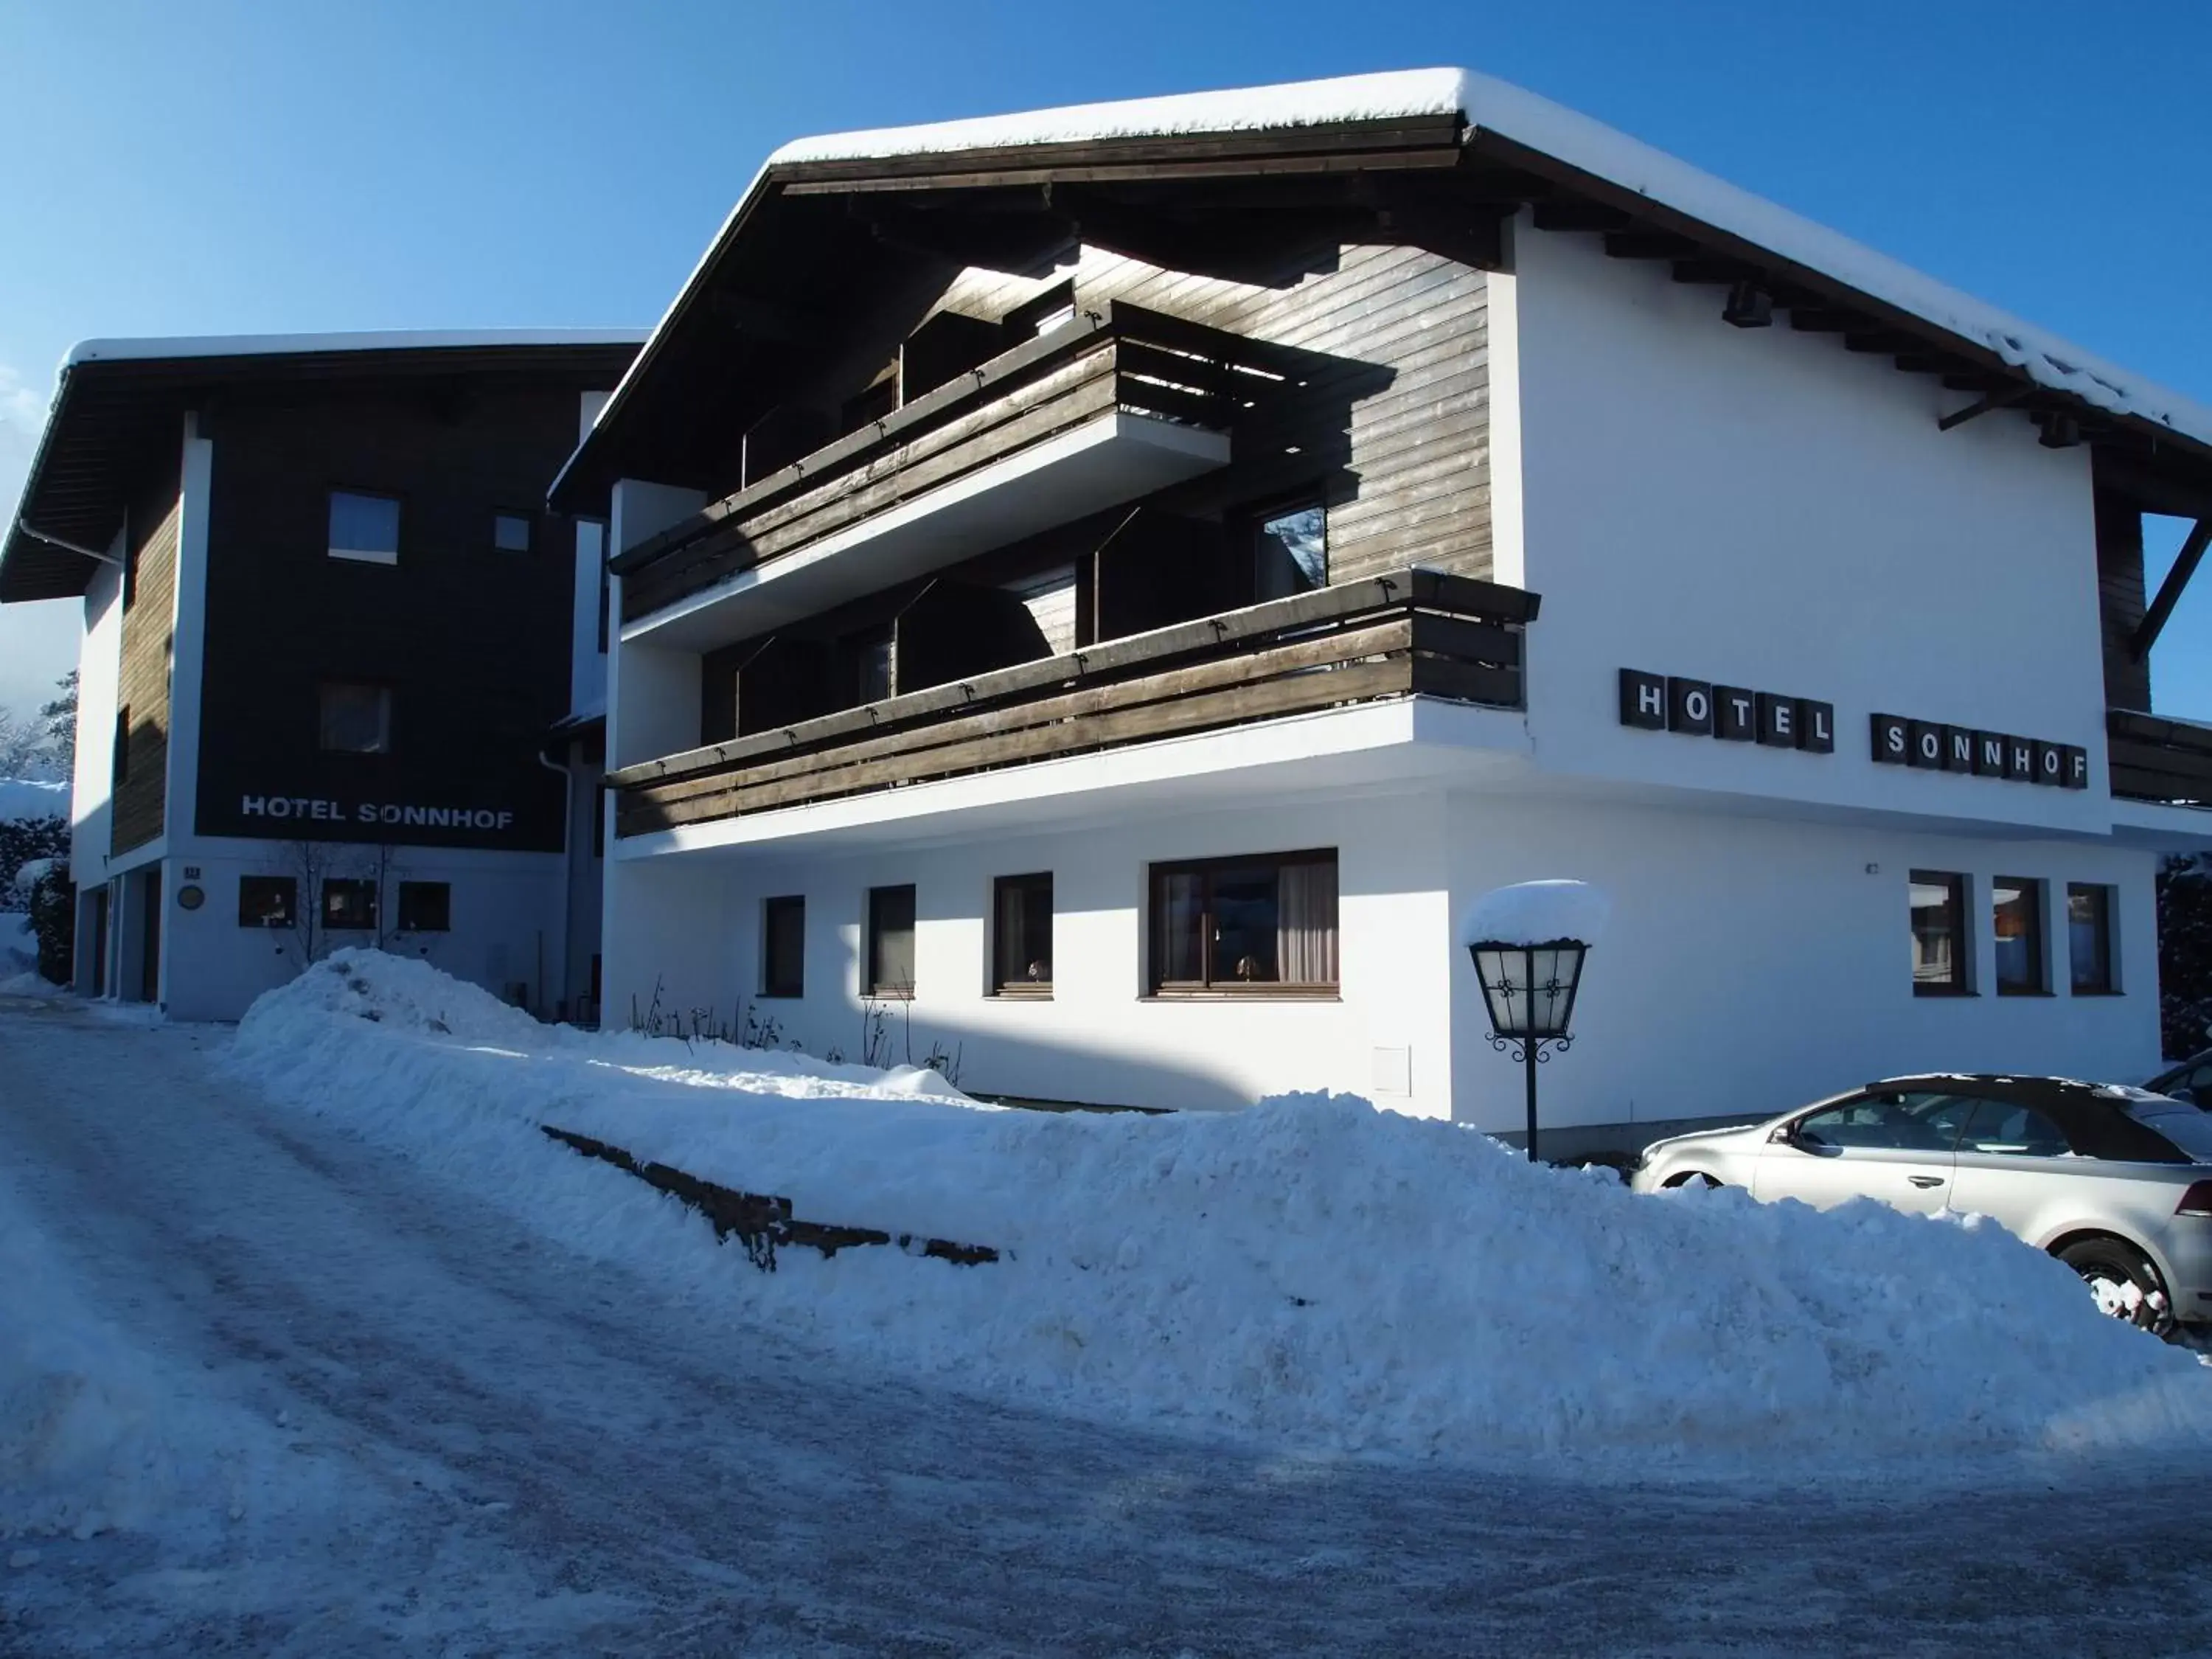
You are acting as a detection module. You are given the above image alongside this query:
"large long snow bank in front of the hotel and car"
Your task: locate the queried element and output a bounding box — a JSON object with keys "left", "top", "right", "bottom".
{"left": 230, "top": 951, "right": 2212, "bottom": 1473}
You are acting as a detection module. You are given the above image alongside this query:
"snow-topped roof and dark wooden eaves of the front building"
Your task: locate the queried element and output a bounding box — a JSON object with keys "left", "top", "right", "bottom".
{"left": 553, "top": 69, "right": 2212, "bottom": 520}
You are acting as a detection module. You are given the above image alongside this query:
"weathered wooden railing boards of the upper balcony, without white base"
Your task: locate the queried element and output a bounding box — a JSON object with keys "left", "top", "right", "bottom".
{"left": 613, "top": 301, "right": 1298, "bottom": 622}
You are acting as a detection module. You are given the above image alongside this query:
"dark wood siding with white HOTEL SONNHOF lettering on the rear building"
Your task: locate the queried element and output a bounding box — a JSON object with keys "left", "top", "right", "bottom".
{"left": 199, "top": 376, "right": 584, "bottom": 852}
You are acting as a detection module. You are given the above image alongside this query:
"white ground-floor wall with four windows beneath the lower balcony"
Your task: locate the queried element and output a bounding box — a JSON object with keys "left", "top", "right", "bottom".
{"left": 646, "top": 794, "right": 1451, "bottom": 1115}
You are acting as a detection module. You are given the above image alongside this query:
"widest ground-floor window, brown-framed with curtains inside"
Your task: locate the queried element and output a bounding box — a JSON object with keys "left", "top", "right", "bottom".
{"left": 1152, "top": 849, "right": 1336, "bottom": 995}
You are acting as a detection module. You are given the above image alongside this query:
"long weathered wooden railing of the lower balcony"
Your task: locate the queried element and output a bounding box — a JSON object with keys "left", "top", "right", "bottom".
{"left": 608, "top": 568, "right": 1537, "bottom": 836}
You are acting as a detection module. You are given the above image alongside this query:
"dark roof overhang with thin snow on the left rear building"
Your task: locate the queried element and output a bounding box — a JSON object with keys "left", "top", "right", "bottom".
{"left": 0, "top": 330, "right": 644, "bottom": 604}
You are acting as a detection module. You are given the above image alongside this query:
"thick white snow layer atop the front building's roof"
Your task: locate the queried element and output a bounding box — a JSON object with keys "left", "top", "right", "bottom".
{"left": 768, "top": 69, "right": 2212, "bottom": 445}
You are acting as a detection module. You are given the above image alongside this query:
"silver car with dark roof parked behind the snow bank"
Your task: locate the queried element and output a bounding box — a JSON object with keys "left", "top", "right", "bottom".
{"left": 1630, "top": 1075, "right": 2212, "bottom": 1332}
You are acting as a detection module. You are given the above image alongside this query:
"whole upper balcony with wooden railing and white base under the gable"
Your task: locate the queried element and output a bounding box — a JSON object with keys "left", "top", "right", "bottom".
{"left": 615, "top": 303, "right": 1310, "bottom": 650}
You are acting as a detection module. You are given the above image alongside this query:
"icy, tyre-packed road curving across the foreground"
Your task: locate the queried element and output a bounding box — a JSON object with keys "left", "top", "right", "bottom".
{"left": 0, "top": 1000, "right": 2212, "bottom": 1659}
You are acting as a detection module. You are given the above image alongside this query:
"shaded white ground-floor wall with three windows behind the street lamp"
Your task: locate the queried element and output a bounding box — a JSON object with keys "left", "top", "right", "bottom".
{"left": 1449, "top": 794, "right": 2159, "bottom": 1139}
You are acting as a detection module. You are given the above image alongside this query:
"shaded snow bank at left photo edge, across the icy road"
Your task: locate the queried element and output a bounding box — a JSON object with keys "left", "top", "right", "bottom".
{"left": 0, "top": 1175, "right": 301, "bottom": 1537}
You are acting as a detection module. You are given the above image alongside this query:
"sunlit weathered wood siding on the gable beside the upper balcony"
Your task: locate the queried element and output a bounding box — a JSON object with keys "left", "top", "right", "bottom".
{"left": 940, "top": 243, "right": 1491, "bottom": 582}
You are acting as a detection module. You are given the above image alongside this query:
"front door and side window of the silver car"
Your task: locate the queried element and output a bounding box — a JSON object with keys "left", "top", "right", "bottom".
{"left": 1752, "top": 1091, "right": 1973, "bottom": 1214}
